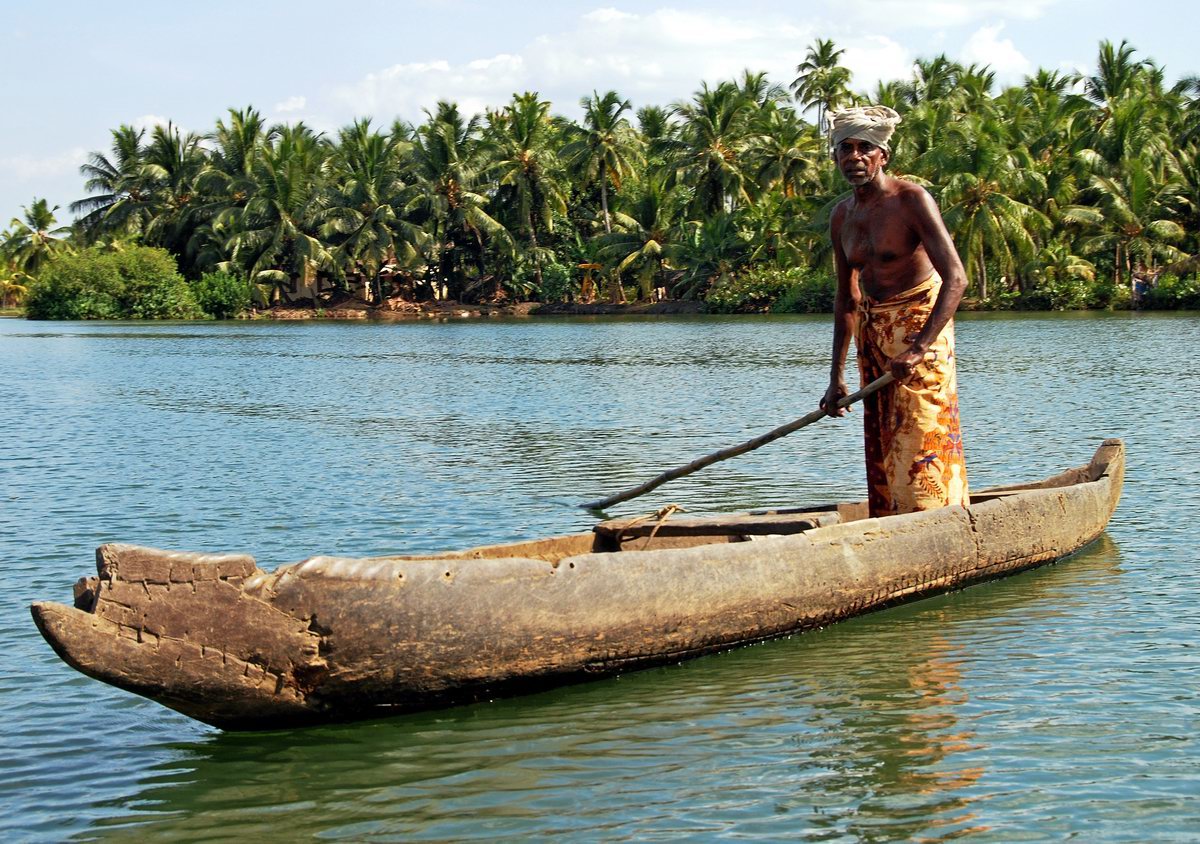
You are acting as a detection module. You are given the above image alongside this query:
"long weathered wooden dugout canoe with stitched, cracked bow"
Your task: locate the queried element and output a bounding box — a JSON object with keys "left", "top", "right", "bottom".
{"left": 31, "top": 439, "right": 1124, "bottom": 730}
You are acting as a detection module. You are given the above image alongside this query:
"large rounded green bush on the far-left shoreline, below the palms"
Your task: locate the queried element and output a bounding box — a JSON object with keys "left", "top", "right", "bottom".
{"left": 25, "top": 246, "right": 203, "bottom": 319}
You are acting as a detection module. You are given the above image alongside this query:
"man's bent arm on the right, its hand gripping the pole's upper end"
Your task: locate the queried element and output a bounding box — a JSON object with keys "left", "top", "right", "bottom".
{"left": 892, "top": 186, "right": 967, "bottom": 381}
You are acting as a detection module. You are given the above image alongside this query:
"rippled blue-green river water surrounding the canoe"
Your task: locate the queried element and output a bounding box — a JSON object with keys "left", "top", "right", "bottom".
{"left": 0, "top": 315, "right": 1200, "bottom": 842}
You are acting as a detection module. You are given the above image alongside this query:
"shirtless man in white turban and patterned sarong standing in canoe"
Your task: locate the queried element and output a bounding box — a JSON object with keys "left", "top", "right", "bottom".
{"left": 821, "top": 106, "right": 970, "bottom": 516}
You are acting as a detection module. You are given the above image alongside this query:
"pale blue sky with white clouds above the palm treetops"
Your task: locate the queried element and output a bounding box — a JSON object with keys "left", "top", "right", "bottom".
{"left": 0, "top": 0, "right": 1200, "bottom": 228}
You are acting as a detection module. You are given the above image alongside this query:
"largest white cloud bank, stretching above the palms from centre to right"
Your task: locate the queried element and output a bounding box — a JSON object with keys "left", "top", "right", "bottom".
{"left": 324, "top": 0, "right": 1063, "bottom": 124}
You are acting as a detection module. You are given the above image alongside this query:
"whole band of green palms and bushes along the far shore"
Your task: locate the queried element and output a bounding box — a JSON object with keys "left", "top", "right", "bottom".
{"left": 7, "top": 40, "right": 1200, "bottom": 319}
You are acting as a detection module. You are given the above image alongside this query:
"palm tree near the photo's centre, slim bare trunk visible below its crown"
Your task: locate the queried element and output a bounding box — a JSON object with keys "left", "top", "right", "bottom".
{"left": 563, "top": 91, "right": 644, "bottom": 233}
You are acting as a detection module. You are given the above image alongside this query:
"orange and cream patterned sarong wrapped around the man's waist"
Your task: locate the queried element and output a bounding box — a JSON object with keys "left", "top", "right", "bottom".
{"left": 854, "top": 273, "right": 971, "bottom": 516}
